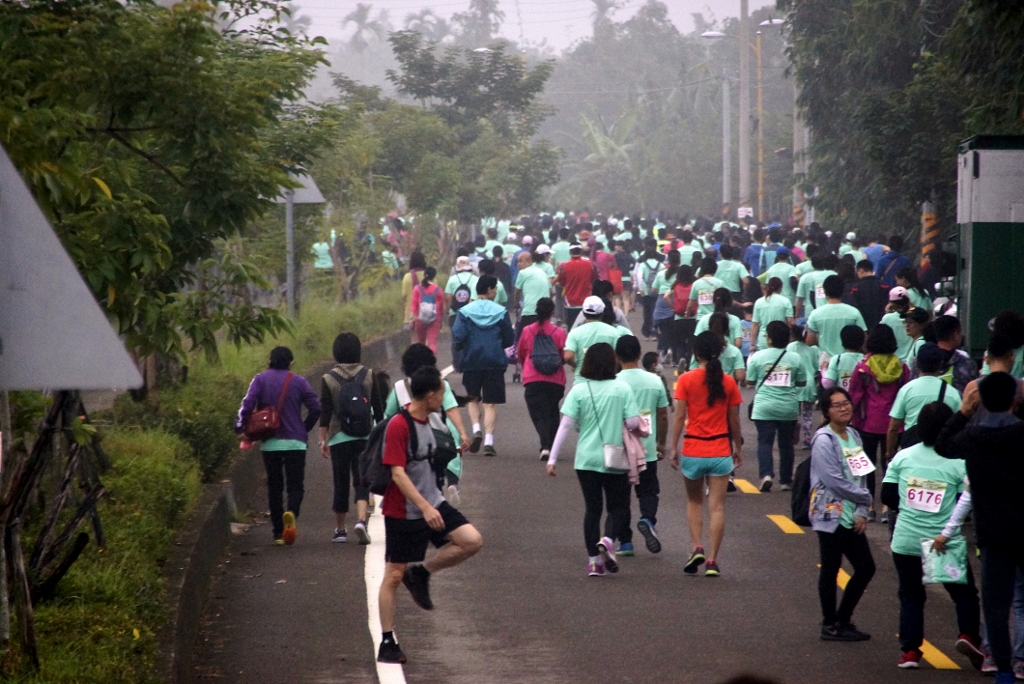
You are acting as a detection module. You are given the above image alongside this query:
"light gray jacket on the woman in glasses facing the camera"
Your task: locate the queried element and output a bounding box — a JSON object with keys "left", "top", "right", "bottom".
{"left": 810, "top": 425, "right": 874, "bottom": 532}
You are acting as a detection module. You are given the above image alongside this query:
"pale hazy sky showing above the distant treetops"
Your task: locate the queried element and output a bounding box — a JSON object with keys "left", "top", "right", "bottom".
{"left": 294, "top": 0, "right": 775, "bottom": 51}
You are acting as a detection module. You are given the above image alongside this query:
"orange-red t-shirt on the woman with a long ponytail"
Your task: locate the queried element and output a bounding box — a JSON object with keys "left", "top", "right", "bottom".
{"left": 675, "top": 369, "right": 743, "bottom": 458}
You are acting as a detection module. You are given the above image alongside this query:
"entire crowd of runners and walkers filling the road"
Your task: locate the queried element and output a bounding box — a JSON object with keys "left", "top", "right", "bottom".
{"left": 236, "top": 214, "right": 1024, "bottom": 683}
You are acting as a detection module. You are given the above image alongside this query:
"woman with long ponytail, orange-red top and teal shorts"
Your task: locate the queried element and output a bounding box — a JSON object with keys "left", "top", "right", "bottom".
{"left": 669, "top": 331, "right": 743, "bottom": 578}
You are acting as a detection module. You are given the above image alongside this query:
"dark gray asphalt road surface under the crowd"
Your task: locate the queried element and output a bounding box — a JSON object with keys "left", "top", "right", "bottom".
{"left": 197, "top": 315, "right": 978, "bottom": 684}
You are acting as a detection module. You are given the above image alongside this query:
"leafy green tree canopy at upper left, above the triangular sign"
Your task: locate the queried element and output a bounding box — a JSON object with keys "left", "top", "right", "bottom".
{"left": 0, "top": 0, "right": 335, "bottom": 356}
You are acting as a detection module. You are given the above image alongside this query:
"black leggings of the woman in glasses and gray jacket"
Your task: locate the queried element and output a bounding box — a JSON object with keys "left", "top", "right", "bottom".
{"left": 818, "top": 524, "right": 874, "bottom": 626}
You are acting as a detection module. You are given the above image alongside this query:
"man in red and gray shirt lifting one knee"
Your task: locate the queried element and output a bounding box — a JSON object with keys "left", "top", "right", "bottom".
{"left": 377, "top": 367, "right": 483, "bottom": 662}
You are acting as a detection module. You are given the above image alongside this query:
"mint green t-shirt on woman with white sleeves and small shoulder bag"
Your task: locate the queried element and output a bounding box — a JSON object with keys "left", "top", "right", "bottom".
{"left": 562, "top": 376, "right": 638, "bottom": 473}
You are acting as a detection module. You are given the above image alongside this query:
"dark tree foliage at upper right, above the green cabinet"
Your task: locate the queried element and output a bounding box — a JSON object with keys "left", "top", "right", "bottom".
{"left": 779, "top": 0, "right": 1024, "bottom": 234}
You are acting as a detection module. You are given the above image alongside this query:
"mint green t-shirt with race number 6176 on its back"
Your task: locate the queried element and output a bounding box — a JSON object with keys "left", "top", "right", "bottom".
{"left": 882, "top": 444, "right": 967, "bottom": 556}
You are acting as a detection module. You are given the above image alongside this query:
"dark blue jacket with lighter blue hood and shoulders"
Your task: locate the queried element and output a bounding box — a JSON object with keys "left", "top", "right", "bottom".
{"left": 452, "top": 299, "right": 515, "bottom": 372}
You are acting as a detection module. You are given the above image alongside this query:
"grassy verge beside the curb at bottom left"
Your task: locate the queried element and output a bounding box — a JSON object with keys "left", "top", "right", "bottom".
{"left": 8, "top": 429, "right": 200, "bottom": 684}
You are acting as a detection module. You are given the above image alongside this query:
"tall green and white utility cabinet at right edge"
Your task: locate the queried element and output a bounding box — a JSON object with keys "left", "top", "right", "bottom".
{"left": 956, "top": 135, "right": 1024, "bottom": 358}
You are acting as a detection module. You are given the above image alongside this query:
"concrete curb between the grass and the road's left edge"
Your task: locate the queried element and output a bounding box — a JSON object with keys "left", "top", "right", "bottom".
{"left": 156, "top": 331, "right": 410, "bottom": 684}
